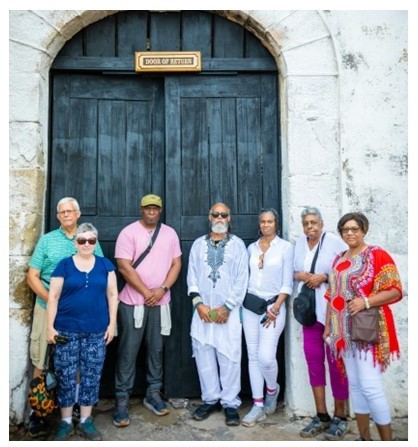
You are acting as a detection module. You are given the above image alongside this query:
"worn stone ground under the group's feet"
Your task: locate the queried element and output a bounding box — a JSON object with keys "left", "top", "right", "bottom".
{"left": 9, "top": 398, "right": 408, "bottom": 443}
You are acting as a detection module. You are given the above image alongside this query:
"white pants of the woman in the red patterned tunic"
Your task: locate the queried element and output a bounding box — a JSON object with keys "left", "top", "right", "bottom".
{"left": 343, "top": 349, "right": 391, "bottom": 425}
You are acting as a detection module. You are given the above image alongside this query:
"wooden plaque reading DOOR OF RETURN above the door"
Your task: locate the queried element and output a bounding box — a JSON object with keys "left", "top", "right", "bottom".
{"left": 135, "top": 51, "right": 202, "bottom": 72}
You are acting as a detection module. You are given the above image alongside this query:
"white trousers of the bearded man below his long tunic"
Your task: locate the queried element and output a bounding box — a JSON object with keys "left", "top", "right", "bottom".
{"left": 192, "top": 339, "right": 241, "bottom": 408}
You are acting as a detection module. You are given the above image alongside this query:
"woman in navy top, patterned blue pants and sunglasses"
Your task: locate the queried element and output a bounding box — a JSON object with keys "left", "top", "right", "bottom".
{"left": 47, "top": 223, "right": 118, "bottom": 441}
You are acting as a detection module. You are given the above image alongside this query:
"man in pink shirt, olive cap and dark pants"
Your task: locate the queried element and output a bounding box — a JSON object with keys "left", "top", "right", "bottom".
{"left": 113, "top": 194, "right": 181, "bottom": 427}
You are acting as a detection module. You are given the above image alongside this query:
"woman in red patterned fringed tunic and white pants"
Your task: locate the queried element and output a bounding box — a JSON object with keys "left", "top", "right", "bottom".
{"left": 324, "top": 213, "right": 402, "bottom": 441}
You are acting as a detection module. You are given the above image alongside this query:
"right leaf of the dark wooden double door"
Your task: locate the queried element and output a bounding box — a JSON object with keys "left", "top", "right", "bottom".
{"left": 165, "top": 74, "right": 280, "bottom": 396}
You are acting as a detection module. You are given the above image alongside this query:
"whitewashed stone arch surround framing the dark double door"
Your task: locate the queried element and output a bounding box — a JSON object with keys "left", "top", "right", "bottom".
{"left": 9, "top": 11, "right": 340, "bottom": 423}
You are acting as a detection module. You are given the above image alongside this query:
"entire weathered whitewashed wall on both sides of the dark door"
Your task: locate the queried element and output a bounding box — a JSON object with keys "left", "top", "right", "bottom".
{"left": 9, "top": 10, "right": 408, "bottom": 424}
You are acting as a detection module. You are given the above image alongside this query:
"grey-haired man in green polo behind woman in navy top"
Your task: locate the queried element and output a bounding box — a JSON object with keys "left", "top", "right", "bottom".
{"left": 27, "top": 197, "right": 103, "bottom": 438}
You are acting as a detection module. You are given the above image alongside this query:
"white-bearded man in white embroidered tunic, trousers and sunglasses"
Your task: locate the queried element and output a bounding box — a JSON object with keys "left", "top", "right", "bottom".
{"left": 187, "top": 203, "right": 248, "bottom": 425}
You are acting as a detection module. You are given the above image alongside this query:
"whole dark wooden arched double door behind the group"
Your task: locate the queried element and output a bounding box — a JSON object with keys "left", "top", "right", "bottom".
{"left": 46, "top": 11, "right": 283, "bottom": 396}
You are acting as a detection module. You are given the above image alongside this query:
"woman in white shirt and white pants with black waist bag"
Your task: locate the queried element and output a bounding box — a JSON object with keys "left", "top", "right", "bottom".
{"left": 241, "top": 208, "right": 293, "bottom": 427}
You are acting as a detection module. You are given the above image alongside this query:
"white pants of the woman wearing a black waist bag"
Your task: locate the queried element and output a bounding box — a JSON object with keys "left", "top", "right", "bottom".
{"left": 242, "top": 305, "right": 286, "bottom": 399}
